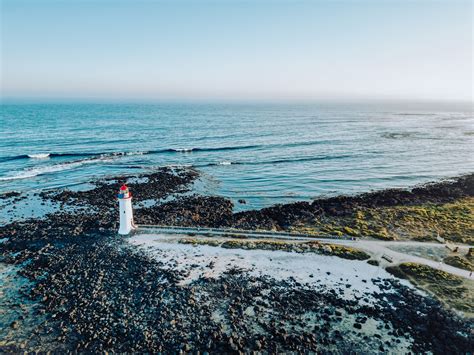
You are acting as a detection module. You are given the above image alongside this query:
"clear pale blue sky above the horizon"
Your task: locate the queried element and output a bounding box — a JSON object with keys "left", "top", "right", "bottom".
{"left": 0, "top": 0, "right": 473, "bottom": 101}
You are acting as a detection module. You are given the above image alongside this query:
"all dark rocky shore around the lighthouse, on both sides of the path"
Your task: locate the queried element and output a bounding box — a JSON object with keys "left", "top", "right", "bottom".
{"left": 0, "top": 168, "right": 474, "bottom": 354}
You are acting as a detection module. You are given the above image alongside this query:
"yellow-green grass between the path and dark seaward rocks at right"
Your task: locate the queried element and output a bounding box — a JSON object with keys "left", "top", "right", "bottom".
{"left": 290, "top": 197, "right": 474, "bottom": 244}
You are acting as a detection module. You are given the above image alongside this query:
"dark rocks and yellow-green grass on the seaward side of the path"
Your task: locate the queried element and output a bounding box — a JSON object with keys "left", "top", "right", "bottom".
{"left": 4, "top": 168, "right": 474, "bottom": 244}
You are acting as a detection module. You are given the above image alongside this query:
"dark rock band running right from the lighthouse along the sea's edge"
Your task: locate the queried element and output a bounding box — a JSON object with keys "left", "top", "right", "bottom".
{"left": 132, "top": 174, "right": 474, "bottom": 234}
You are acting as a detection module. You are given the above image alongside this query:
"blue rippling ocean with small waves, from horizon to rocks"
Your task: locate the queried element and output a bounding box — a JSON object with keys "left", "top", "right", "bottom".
{"left": 0, "top": 103, "right": 474, "bottom": 210}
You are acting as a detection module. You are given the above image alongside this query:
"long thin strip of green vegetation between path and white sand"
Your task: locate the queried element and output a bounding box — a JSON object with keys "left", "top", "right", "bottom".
{"left": 179, "top": 238, "right": 370, "bottom": 260}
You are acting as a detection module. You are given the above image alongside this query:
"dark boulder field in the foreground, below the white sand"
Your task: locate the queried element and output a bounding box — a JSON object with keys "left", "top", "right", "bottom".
{"left": 2, "top": 236, "right": 473, "bottom": 353}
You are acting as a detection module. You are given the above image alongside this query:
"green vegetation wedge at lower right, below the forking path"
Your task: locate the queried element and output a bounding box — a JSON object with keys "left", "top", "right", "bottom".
{"left": 387, "top": 263, "right": 474, "bottom": 314}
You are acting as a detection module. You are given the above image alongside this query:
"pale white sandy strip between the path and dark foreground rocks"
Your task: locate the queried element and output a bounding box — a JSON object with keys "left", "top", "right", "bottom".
{"left": 129, "top": 234, "right": 409, "bottom": 302}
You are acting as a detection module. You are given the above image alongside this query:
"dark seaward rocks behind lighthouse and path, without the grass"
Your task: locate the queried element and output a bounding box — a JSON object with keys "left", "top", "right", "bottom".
{"left": 0, "top": 168, "right": 474, "bottom": 241}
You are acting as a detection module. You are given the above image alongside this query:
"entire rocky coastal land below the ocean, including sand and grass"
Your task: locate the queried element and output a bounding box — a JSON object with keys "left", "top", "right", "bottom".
{"left": 0, "top": 168, "right": 474, "bottom": 353}
